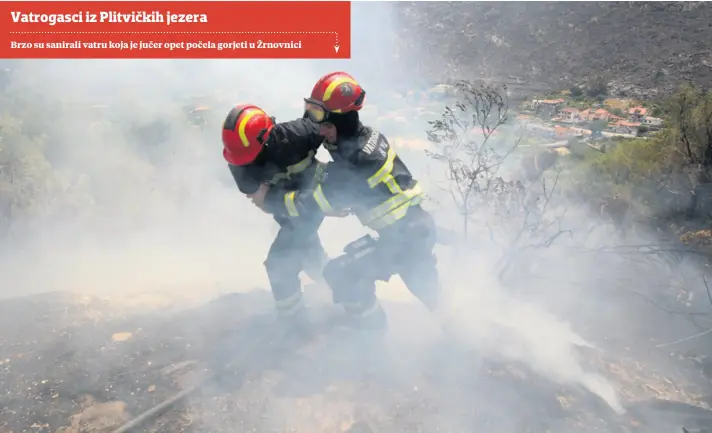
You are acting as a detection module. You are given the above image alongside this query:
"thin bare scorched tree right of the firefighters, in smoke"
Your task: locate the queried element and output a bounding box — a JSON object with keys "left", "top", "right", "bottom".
{"left": 426, "top": 81, "right": 573, "bottom": 286}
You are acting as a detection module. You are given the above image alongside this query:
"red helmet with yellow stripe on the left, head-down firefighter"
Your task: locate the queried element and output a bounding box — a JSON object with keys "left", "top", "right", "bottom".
{"left": 223, "top": 105, "right": 274, "bottom": 165}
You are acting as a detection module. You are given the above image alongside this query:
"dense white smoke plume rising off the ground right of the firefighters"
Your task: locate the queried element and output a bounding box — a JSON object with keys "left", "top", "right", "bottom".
{"left": 446, "top": 258, "right": 625, "bottom": 413}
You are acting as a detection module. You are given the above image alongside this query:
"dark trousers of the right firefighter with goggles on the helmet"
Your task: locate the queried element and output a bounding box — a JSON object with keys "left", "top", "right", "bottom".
{"left": 323, "top": 206, "right": 440, "bottom": 314}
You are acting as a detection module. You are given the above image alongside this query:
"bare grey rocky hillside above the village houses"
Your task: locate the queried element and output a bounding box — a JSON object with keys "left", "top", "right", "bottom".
{"left": 396, "top": 2, "right": 712, "bottom": 96}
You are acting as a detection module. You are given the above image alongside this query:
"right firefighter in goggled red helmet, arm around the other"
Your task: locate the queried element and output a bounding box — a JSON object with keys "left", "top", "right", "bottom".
{"left": 265, "top": 72, "right": 439, "bottom": 330}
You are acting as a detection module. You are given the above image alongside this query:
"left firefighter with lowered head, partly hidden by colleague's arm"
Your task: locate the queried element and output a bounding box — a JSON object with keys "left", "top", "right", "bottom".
{"left": 222, "top": 105, "right": 327, "bottom": 317}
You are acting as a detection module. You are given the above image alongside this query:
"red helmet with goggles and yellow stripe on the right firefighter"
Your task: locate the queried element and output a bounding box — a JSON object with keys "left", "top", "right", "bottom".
{"left": 304, "top": 72, "right": 366, "bottom": 123}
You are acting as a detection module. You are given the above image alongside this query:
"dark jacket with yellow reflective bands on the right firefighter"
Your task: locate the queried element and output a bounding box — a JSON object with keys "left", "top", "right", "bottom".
{"left": 265, "top": 125, "right": 423, "bottom": 231}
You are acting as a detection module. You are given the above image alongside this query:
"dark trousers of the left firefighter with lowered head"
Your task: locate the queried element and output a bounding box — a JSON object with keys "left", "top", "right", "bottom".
{"left": 264, "top": 213, "right": 327, "bottom": 309}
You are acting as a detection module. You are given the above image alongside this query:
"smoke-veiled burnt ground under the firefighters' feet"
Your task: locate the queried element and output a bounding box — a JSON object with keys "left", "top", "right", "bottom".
{"left": 0, "top": 291, "right": 709, "bottom": 433}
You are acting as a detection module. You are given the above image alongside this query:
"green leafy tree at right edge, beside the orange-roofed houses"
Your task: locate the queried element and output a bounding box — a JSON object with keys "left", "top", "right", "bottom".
{"left": 588, "top": 85, "right": 712, "bottom": 218}
